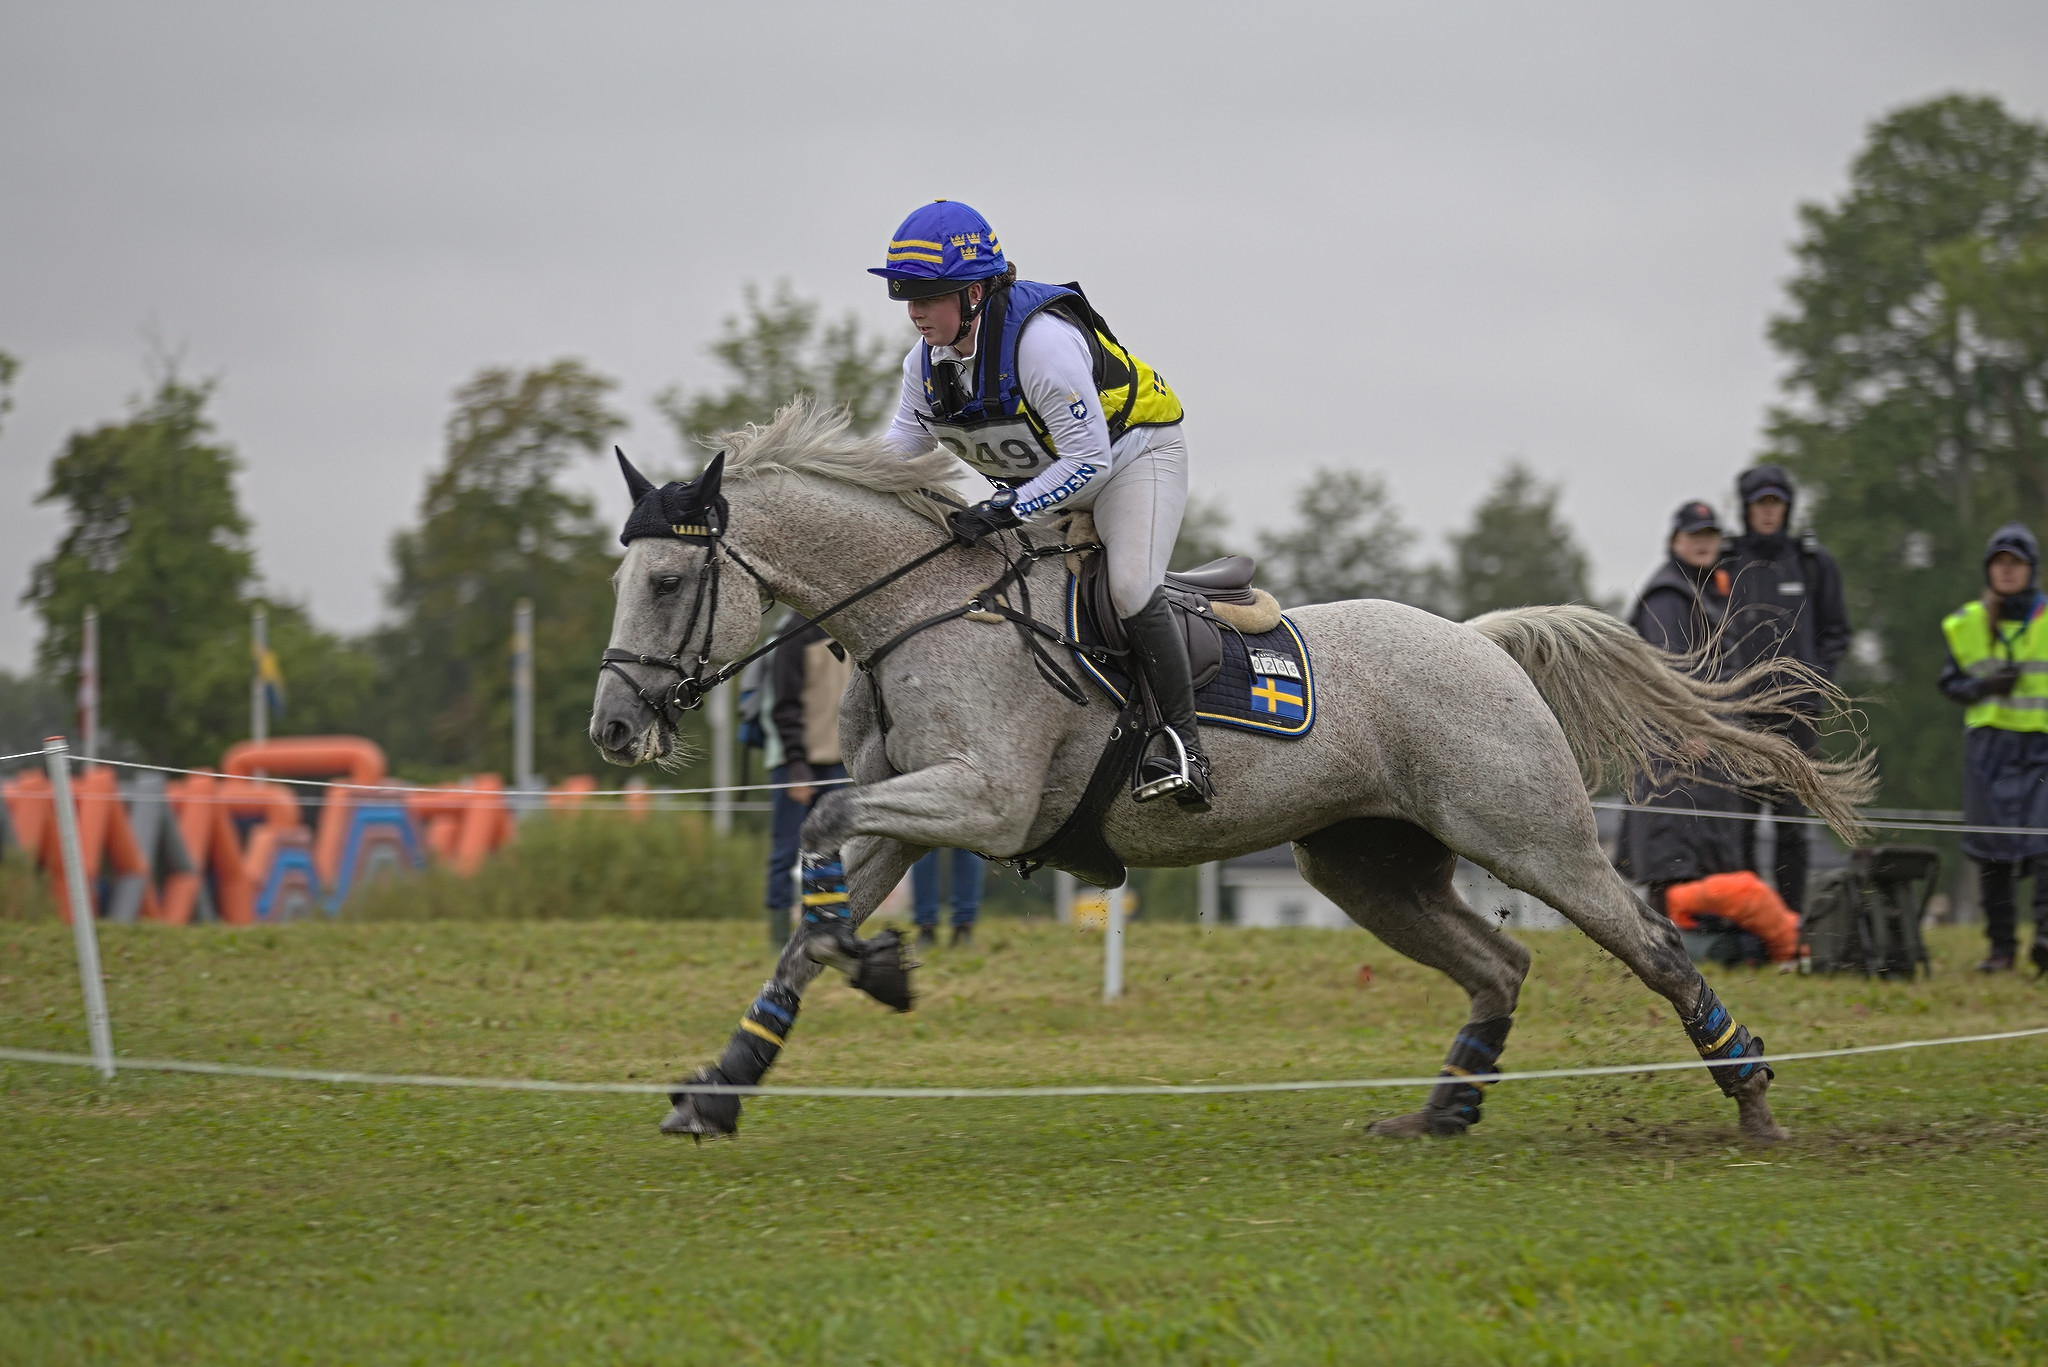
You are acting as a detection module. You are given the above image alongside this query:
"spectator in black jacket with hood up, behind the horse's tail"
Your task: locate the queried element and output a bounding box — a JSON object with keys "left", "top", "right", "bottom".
{"left": 1722, "top": 465, "right": 1849, "bottom": 910}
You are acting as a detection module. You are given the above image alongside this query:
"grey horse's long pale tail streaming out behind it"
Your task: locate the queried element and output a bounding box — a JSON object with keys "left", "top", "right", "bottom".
{"left": 1466, "top": 607, "right": 1878, "bottom": 842}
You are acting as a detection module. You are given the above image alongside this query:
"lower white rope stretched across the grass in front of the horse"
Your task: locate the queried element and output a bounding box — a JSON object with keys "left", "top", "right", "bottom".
{"left": 0, "top": 1027, "right": 2048, "bottom": 1101}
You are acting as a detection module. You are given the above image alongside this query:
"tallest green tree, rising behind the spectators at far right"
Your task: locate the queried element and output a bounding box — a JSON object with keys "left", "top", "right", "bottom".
{"left": 1767, "top": 94, "right": 2048, "bottom": 805}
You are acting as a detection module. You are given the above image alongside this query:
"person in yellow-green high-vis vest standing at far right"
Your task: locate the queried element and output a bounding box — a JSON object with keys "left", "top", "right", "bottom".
{"left": 1939, "top": 523, "right": 2048, "bottom": 974}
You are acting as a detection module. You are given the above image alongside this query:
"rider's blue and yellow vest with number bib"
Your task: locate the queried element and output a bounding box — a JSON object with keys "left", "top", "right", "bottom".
{"left": 924, "top": 281, "right": 1182, "bottom": 486}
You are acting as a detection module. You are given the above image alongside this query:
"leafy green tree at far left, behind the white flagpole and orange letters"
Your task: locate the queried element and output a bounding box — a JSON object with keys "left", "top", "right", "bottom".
{"left": 23, "top": 375, "right": 254, "bottom": 764}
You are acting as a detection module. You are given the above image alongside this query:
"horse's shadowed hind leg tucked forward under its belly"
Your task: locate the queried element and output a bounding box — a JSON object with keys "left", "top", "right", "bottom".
{"left": 1294, "top": 818, "right": 1530, "bottom": 1135}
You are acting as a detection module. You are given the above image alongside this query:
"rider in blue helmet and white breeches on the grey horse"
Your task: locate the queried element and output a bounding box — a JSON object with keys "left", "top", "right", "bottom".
{"left": 870, "top": 199, "right": 1214, "bottom": 812}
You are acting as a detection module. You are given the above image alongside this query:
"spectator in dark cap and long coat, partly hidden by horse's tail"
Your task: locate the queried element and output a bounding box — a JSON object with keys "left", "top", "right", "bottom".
{"left": 1622, "top": 502, "right": 1753, "bottom": 957}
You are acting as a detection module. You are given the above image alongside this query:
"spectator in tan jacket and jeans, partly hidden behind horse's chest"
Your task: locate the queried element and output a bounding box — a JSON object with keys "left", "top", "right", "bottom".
{"left": 764, "top": 627, "right": 854, "bottom": 945}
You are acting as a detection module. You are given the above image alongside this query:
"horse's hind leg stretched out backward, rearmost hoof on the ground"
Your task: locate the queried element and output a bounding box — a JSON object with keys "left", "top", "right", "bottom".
{"left": 1491, "top": 844, "right": 1790, "bottom": 1144}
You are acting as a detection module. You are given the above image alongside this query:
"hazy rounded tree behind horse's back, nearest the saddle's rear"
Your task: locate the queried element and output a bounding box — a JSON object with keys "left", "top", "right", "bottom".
{"left": 1260, "top": 467, "right": 1419, "bottom": 607}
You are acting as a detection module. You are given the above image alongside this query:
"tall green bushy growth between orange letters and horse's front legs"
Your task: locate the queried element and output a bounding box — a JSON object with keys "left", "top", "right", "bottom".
{"left": 342, "top": 812, "right": 768, "bottom": 920}
